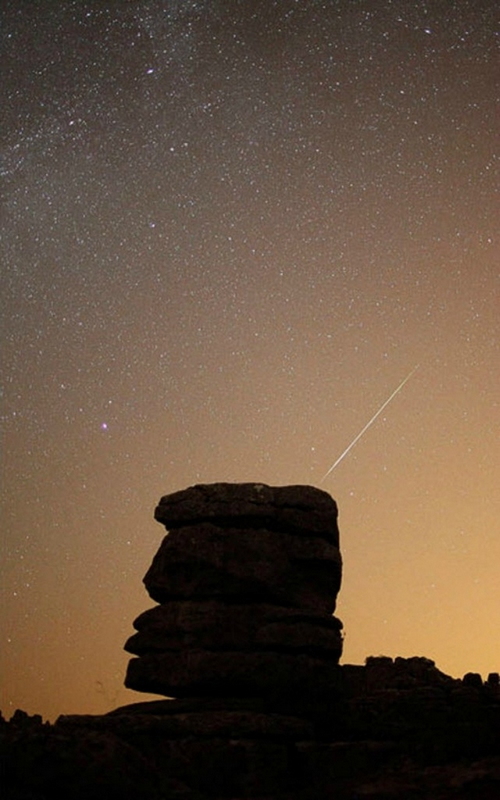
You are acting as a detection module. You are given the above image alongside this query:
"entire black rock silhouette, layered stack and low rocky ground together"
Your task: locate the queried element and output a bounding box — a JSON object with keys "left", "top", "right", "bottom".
{"left": 0, "top": 483, "right": 500, "bottom": 800}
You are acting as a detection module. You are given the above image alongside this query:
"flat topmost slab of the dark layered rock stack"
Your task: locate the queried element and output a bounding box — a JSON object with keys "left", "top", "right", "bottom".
{"left": 155, "top": 483, "right": 339, "bottom": 547}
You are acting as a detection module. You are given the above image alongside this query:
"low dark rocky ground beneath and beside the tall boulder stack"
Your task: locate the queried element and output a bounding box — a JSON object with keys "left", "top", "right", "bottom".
{"left": 0, "top": 658, "right": 500, "bottom": 800}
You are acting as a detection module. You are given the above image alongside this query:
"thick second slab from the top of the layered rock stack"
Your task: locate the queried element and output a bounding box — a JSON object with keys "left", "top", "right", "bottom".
{"left": 144, "top": 523, "right": 342, "bottom": 614}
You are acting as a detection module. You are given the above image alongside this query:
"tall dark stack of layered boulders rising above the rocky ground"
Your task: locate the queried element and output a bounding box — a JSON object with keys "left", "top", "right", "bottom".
{"left": 125, "top": 483, "right": 342, "bottom": 709}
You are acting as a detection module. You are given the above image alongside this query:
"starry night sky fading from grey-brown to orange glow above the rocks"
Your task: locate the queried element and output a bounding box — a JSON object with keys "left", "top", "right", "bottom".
{"left": 0, "top": 0, "right": 500, "bottom": 718}
